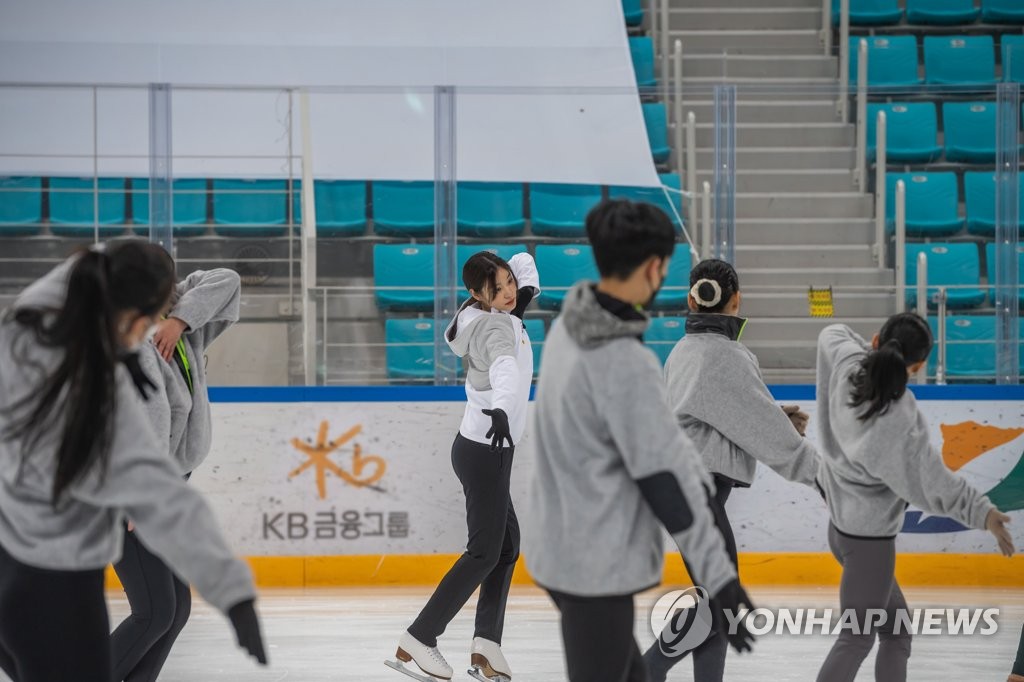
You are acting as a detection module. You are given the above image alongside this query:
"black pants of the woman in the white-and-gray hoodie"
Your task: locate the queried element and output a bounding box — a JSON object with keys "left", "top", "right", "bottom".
{"left": 409, "top": 434, "right": 519, "bottom": 646}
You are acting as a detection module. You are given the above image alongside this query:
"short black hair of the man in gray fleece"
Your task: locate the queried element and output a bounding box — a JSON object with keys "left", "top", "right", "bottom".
{"left": 587, "top": 199, "right": 676, "bottom": 280}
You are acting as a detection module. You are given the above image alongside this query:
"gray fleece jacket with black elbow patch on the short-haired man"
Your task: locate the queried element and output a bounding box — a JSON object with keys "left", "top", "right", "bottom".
{"left": 522, "top": 282, "right": 736, "bottom": 597}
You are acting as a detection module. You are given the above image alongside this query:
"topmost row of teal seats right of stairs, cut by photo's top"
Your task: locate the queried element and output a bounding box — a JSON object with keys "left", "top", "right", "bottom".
{"left": 833, "top": 0, "right": 1024, "bottom": 26}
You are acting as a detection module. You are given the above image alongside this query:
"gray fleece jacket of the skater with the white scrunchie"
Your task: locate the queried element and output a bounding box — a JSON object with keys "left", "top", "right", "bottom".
{"left": 665, "top": 313, "right": 818, "bottom": 485}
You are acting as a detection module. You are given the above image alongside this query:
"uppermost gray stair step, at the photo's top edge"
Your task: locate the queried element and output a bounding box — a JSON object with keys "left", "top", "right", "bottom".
{"left": 669, "top": 5, "right": 821, "bottom": 31}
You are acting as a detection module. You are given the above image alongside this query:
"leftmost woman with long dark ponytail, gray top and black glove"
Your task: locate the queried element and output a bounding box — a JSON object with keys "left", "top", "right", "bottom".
{"left": 0, "top": 240, "right": 266, "bottom": 682}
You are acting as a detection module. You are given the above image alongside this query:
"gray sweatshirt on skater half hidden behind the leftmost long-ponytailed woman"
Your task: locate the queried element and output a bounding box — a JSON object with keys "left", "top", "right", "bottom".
{"left": 139, "top": 269, "right": 242, "bottom": 474}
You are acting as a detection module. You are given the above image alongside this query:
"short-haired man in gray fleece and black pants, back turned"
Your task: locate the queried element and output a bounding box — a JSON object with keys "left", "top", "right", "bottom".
{"left": 524, "top": 200, "right": 753, "bottom": 682}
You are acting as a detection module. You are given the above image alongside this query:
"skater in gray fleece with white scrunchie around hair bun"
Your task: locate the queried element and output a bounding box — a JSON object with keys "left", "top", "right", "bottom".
{"left": 644, "top": 259, "right": 818, "bottom": 682}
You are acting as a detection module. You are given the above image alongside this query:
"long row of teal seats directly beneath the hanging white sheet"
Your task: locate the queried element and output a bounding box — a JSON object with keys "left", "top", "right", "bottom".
{"left": 0, "top": 173, "right": 681, "bottom": 238}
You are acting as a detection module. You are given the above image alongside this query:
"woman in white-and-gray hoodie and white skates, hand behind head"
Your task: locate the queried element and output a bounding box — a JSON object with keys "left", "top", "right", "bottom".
{"left": 387, "top": 251, "right": 541, "bottom": 680}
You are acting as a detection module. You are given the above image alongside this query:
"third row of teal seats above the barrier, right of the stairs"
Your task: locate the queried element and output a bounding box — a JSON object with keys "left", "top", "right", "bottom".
{"left": 886, "top": 172, "right": 1024, "bottom": 238}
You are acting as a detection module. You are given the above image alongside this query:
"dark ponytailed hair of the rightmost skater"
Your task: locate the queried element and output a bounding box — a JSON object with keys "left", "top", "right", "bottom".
{"left": 850, "top": 312, "right": 932, "bottom": 421}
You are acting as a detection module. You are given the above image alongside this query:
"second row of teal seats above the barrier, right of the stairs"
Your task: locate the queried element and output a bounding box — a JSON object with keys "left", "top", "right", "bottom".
{"left": 905, "top": 236, "right": 1024, "bottom": 310}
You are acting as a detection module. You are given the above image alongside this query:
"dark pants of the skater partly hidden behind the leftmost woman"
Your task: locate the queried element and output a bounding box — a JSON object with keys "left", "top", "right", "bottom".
{"left": 110, "top": 532, "right": 191, "bottom": 682}
